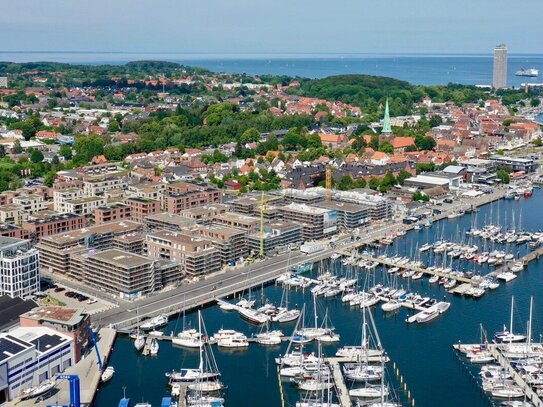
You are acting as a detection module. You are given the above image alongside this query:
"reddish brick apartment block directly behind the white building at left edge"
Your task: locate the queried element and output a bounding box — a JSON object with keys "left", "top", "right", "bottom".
{"left": 22, "top": 213, "right": 85, "bottom": 240}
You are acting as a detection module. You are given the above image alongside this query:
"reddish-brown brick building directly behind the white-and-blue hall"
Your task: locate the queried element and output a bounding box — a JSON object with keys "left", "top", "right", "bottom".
{"left": 19, "top": 306, "right": 91, "bottom": 363}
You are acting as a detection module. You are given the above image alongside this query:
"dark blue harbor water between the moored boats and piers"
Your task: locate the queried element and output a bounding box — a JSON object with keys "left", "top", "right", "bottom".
{"left": 96, "top": 189, "right": 543, "bottom": 407}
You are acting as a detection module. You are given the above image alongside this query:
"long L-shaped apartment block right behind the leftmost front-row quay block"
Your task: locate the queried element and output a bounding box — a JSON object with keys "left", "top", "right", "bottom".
{"left": 36, "top": 220, "right": 143, "bottom": 277}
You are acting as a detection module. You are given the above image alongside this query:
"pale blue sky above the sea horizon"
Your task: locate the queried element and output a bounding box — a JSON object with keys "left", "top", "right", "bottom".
{"left": 0, "top": 0, "right": 543, "bottom": 54}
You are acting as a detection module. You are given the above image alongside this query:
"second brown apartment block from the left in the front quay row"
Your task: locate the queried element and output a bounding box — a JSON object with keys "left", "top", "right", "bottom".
{"left": 145, "top": 230, "right": 221, "bottom": 276}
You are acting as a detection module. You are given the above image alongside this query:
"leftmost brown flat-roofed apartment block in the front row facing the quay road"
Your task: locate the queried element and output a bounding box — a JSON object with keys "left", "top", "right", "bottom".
{"left": 71, "top": 249, "right": 161, "bottom": 299}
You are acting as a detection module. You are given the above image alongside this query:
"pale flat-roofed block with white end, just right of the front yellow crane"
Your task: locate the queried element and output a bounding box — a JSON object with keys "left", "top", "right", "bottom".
{"left": 279, "top": 202, "right": 338, "bottom": 240}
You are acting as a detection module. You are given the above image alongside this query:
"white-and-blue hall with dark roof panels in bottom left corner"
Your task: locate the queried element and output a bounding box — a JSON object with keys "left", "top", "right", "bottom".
{"left": 0, "top": 326, "right": 75, "bottom": 404}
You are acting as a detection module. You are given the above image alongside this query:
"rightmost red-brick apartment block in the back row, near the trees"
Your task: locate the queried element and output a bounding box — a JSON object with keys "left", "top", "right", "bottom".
{"left": 164, "top": 182, "right": 223, "bottom": 213}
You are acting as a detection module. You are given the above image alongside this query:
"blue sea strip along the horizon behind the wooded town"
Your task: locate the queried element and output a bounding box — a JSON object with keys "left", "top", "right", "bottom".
{"left": 0, "top": 51, "right": 543, "bottom": 87}
